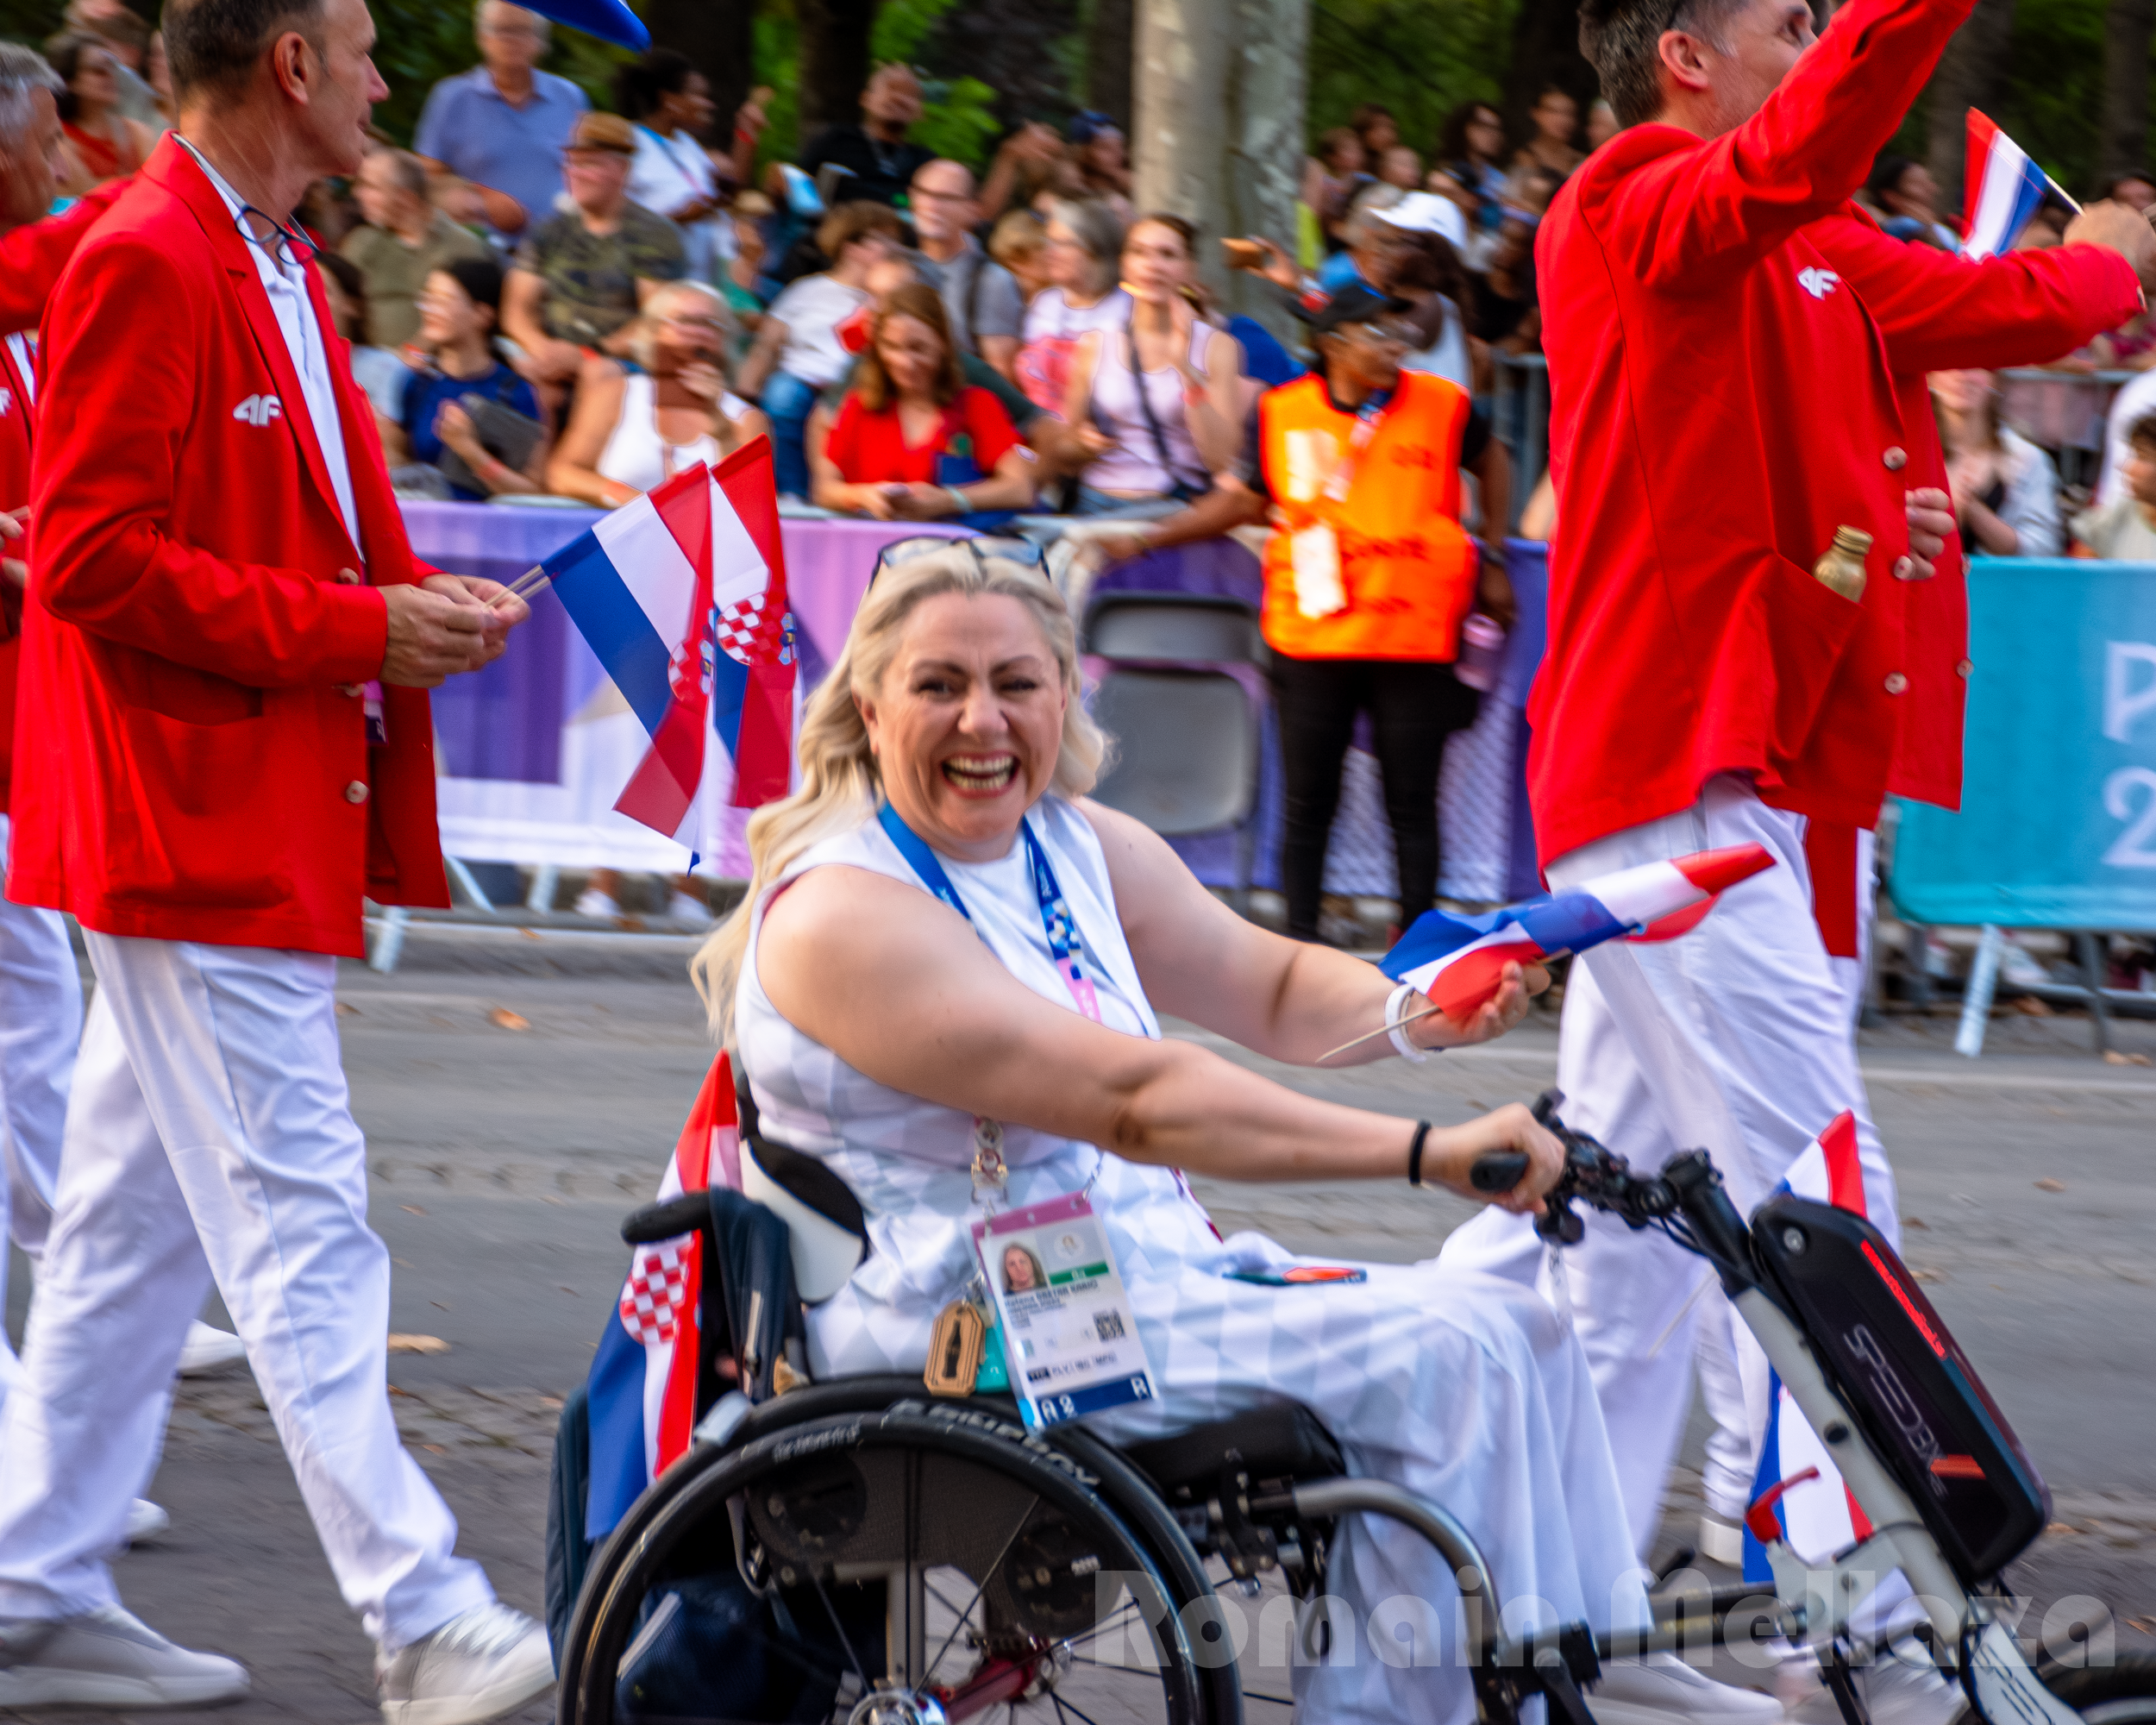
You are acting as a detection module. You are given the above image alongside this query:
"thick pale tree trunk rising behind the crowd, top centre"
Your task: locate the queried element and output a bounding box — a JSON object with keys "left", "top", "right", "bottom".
{"left": 1132, "top": 0, "right": 1311, "bottom": 335}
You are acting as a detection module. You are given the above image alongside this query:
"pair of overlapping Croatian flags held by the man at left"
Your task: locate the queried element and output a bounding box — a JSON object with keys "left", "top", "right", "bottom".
{"left": 543, "top": 438, "right": 793, "bottom": 854}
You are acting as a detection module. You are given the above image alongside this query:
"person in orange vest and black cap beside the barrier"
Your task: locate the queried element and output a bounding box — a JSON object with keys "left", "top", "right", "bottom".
{"left": 1102, "top": 283, "right": 1512, "bottom": 940}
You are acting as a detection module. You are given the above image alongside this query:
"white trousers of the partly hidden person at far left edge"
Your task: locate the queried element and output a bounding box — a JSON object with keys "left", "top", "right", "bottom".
{"left": 0, "top": 815, "right": 82, "bottom": 1406}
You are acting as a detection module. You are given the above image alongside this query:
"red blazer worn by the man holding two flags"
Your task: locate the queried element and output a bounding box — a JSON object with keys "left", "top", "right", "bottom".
{"left": 9, "top": 138, "right": 448, "bottom": 957}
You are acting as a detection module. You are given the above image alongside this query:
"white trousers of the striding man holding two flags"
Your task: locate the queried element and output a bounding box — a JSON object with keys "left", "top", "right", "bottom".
{"left": 0, "top": 934, "right": 494, "bottom": 1647}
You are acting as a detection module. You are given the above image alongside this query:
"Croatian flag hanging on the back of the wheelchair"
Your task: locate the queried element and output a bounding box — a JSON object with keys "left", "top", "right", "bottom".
{"left": 585, "top": 1055, "right": 742, "bottom": 1540}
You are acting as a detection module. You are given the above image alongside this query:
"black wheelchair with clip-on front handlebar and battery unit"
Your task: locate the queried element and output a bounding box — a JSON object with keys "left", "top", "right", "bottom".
{"left": 559, "top": 1094, "right": 2156, "bottom": 1725}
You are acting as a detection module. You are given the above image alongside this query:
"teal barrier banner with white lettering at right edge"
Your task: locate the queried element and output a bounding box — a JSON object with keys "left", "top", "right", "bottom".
{"left": 1891, "top": 556, "right": 2156, "bottom": 932}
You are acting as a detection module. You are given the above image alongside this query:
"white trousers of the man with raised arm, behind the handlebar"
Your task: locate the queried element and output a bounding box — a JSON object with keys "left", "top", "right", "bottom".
{"left": 1443, "top": 775, "right": 1900, "bottom": 1555}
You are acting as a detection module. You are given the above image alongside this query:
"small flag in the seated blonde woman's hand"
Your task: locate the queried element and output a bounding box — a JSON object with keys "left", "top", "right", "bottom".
{"left": 1378, "top": 845, "right": 1775, "bottom": 1025}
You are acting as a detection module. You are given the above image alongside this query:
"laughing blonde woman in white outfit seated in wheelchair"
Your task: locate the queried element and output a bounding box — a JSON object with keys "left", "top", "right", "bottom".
{"left": 699, "top": 543, "right": 1781, "bottom": 1725}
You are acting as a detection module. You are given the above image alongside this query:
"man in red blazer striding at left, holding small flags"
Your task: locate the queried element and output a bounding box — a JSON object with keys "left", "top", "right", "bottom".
{"left": 0, "top": 0, "right": 552, "bottom": 1725}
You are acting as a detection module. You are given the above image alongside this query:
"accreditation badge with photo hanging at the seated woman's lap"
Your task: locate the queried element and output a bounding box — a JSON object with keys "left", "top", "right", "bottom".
{"left": 973, "top": 1193, "right": 1160, "bottom": 1430}
